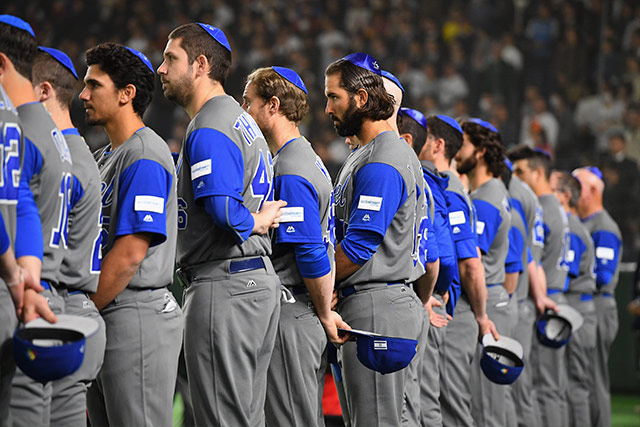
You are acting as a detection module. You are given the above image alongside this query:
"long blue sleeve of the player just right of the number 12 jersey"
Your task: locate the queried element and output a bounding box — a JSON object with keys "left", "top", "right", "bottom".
{"left": 15, "top": 138, "right": 44, "bottom": 260}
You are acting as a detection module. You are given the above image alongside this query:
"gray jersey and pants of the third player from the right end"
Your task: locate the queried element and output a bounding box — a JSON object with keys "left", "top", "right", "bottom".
{"left": 530, "top": 194, "right": 569, "bottom": 426}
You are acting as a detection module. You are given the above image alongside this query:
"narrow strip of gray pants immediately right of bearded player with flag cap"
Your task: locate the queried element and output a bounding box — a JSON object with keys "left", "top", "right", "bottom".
{"left": 420, "top": 294, "right": 447, "bottom": 427}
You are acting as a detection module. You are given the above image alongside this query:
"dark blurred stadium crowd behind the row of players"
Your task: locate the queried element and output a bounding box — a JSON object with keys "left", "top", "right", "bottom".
{"left": 3, "top": 0, "right": 640, "bottom": 261}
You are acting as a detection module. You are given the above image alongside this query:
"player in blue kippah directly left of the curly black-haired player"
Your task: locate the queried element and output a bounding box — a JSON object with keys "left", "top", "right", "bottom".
{"left": 32, "top": 47, "right": 106, "bottom": 426}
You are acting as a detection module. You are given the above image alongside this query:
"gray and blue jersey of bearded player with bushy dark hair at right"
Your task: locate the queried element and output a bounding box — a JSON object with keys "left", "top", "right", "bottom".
{"left": 470, "top": 178, "right": 511, "bottom": 285}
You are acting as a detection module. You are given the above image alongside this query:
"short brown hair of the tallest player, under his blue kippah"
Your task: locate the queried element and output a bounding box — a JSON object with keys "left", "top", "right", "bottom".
{"left": 169, "top": 23, "right": 231, "bottom": 86}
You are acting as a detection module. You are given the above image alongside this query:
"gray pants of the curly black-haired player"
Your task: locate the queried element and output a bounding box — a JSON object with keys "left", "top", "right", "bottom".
{"left": 87, "top": 288, "right": 182, "bottom": 426}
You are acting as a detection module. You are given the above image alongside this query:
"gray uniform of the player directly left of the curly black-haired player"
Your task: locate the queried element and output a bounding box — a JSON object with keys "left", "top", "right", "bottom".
{"left": 51, "top": 129, "right": 107, "bottom": 426}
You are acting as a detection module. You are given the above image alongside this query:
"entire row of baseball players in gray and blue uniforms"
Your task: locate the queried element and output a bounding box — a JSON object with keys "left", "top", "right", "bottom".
{"left": 0, "top": 15, "right": 620, "bottom": 425}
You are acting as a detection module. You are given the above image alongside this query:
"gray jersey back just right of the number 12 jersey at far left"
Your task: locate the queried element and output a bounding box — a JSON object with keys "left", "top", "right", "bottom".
{"left": 18, "top": 102, "right": 73, "bottom": 284}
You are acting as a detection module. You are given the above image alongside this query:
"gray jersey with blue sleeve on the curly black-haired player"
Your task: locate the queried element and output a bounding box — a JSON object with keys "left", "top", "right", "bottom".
{"left": 94, "top": 127, "right": 178, "bottom": 289}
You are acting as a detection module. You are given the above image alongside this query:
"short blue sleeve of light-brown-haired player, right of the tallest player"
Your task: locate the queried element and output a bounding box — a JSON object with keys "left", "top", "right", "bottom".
{"left": 275, "top": 175, "right": 322, "bottom": 244}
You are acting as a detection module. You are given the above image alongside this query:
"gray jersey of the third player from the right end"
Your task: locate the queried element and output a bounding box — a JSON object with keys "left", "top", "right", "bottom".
{"left": 540, "top": 194, "right": 569, "bottom": 290}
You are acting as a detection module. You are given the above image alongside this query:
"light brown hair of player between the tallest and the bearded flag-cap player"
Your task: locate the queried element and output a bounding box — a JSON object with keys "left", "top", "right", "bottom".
{"left": 247, "top": 67, "right": 309, "bottom": 124}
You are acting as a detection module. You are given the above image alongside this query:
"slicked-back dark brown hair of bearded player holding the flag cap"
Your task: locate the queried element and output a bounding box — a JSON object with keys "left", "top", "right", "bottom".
{"left": 324, "top": 59, "right": 394, "bottom": 120}
